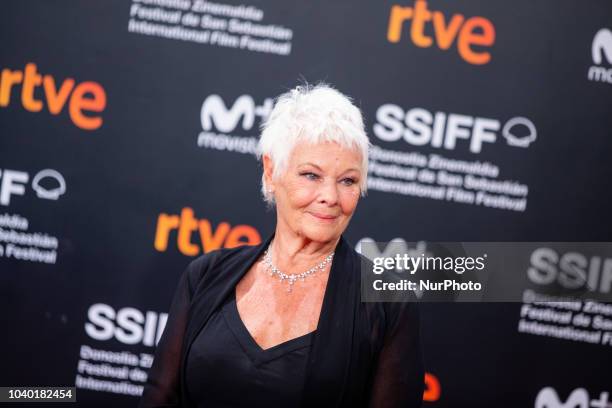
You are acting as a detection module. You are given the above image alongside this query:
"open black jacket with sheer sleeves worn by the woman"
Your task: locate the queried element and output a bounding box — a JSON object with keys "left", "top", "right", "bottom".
{"left": 139, "top": 235, "right": 424, "bottom": 408}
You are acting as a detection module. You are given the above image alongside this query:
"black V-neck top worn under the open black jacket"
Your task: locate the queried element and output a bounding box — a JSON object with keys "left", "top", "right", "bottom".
{"left": 185, "top": 292, "right": 315, "bottom": 407}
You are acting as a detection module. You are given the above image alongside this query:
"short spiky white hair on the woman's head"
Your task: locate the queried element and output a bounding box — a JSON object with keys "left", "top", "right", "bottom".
{"left": 257, "top": 83, "right": 370, "bottom": 204}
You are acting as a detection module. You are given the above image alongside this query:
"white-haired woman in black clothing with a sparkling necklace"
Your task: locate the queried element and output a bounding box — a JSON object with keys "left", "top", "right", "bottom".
{"left": 140, "top": 85, "right": 424, "bottom": 407}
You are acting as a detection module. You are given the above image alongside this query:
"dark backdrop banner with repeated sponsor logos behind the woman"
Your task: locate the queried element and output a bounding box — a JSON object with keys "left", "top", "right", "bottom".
{"left": 0, "top": 0, "right": 612, "bottom": 408}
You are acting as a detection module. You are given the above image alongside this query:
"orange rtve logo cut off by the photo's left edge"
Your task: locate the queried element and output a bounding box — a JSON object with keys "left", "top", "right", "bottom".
{"left": 0, "top": 62, "right": 106, "bottom": 130}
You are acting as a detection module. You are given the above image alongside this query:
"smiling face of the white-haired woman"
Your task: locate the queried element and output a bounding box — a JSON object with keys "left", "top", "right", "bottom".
{"left": 264, "top": 142, "right": 363, "bottom": 242}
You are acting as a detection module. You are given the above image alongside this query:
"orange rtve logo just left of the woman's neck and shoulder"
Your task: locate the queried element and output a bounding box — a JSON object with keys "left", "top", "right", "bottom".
{"left": 154, "top": 207, "right": 261, "bottom": 256}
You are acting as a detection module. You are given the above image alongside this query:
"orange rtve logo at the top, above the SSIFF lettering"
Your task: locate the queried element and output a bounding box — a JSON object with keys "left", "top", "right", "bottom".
{"left": 387, "top": 0, "right": 495, "bottom": 65}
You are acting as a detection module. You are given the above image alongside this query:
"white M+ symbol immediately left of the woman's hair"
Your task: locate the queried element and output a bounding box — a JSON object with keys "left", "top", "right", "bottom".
{"left": 200, "top": 95, "right": 273, "bottom": 133}
